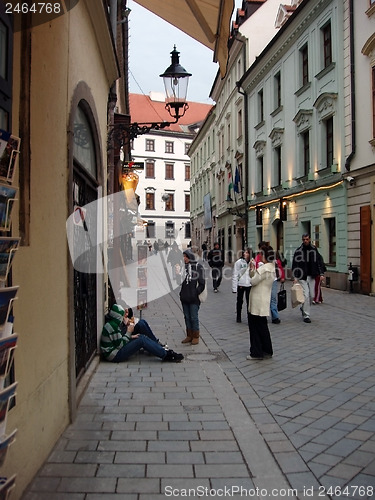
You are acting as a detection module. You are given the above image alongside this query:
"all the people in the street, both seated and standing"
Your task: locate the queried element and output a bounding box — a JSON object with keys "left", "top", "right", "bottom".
{"left": 100, "top": 234, "right": 325, "bottom": 363}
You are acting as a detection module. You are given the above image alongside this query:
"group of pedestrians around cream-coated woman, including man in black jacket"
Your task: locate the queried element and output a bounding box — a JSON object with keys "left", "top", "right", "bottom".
{"left": 232, "top": 233, "right": 326, "bottom": 360}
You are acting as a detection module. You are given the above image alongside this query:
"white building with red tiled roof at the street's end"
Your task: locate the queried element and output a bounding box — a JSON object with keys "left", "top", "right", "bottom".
{"left": 129, "top": 92, "right": 211, "bottom": 249}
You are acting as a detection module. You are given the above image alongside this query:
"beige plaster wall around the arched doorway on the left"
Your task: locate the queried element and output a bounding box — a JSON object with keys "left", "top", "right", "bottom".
{"left": 2, "top": 2, "right": 113, "bottom": 499}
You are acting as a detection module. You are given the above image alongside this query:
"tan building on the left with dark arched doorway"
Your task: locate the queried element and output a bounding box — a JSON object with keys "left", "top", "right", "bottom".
{"left": 0, "top": 0, "right": 119, "bottom": 499}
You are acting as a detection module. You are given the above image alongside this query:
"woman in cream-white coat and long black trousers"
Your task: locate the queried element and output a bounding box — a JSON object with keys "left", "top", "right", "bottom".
{"left": 246, "top": 245, "right": 276, "bottom": 360}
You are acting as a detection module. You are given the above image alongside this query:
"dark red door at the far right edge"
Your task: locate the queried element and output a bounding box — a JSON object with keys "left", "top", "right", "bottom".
{"left": 360, "top": 205, "right": 371, "bottom": 294}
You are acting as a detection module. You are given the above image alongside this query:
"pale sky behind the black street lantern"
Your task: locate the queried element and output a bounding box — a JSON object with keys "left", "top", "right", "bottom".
{"left": 127, "top": 0, "right": 242, "bottom": 104}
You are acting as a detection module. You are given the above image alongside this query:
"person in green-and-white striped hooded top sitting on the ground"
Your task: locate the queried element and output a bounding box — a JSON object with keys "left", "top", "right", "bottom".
{"left": 100, "top": 304, "right": 184, "bottom": 363}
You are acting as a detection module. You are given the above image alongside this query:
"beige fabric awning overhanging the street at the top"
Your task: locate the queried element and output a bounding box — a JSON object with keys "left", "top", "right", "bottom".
{"left": 134, "top": 0, "right": 234, "bottom": 77}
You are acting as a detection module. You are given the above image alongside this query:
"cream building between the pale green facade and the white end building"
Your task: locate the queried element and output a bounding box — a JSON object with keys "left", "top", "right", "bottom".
{"left": 189, "top": 0, "right": 280, "bottom": 263}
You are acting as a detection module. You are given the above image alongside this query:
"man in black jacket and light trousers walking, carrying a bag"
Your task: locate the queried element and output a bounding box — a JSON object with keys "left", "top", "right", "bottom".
{"left": 292, "top": 233, "right": 324, "bottom": 323}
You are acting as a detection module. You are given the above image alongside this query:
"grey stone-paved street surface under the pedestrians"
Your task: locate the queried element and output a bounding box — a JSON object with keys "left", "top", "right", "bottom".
{"left": 23, "top": 264, "right": 375, "bottom": 500}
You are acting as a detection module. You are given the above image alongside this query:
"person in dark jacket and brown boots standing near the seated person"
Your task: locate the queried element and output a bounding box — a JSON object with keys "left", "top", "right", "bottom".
{"left": 180, "top": 249, "right": 206, "bottom": 345}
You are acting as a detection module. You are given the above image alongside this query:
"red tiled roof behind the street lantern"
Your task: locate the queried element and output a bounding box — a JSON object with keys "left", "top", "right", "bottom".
{"left": 129, "top": 94, "right": 212, "bottom": 132}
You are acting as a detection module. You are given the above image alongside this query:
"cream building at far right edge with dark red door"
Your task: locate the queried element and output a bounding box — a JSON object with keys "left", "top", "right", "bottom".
{"left": 344, "top": 0, "right": 375, "bottom": 294}
